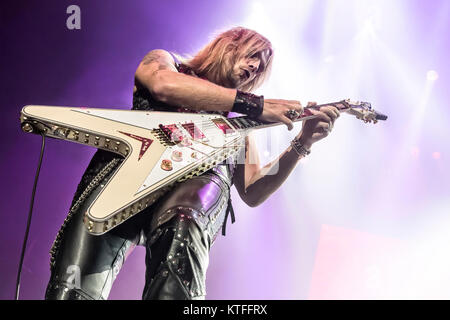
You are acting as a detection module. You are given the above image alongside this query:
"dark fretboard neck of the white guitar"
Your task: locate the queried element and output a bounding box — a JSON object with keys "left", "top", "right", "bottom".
{"left": 227, "top": 101, "right": 349, "bottom": 130}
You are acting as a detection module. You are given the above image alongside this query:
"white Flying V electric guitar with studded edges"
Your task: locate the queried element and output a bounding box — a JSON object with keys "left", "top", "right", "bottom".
{"left": 20, "top": 100, "right": 387, "bottom": 235}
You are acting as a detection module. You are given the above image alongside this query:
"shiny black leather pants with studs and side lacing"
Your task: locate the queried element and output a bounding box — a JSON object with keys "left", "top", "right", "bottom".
{"left": 45, "top": 160, "right": 229, "bottom": 300}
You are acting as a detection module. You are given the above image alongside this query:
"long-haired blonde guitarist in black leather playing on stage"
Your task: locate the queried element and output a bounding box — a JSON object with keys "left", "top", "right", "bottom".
{"left": 45, "top": 27, "right": 339, "bottom": 300}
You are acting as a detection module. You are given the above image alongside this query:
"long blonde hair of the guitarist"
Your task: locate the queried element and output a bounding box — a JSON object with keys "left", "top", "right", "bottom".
{"left": 177, "top": 27, "right": 273, "bottom": 91}
